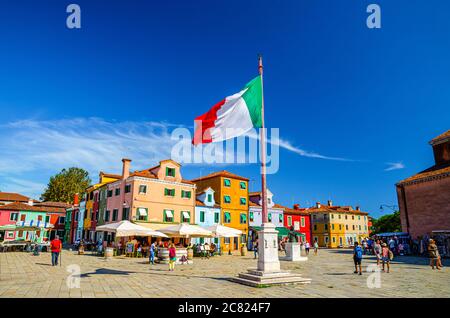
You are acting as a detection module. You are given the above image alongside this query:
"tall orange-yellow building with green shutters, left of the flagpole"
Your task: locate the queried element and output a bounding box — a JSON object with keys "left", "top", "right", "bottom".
{"left": 192, "top": 170, "right": 248, "bottom": 252}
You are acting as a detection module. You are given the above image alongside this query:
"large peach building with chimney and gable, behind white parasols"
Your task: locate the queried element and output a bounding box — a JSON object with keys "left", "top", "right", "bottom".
{"left": 104, "top": 159, "right": 195, "bottom": 239}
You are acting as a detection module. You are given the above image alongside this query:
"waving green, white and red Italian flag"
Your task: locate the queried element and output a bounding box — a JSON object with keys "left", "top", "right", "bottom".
{"left": 192, "top": 76, "right": 262, "bottom": 145}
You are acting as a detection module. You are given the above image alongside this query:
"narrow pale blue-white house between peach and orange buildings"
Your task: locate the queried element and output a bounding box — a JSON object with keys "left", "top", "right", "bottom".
{"left": 192, "top": 187, "right": 221, "bottom": 248}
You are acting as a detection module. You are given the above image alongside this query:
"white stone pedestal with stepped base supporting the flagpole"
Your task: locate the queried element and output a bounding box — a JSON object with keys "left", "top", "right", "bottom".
{"left": 231, "top": 223, "right": 311, "bottom": 287}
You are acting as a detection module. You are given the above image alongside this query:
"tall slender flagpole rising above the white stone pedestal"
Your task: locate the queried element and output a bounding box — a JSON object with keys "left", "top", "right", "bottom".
{"left": 258, "top": 54, "right": 268, "bottom": 224}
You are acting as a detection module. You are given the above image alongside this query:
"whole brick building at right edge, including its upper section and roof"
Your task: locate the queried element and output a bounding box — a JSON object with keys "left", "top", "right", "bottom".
{"left": 396, "top": 130, "right": 450, "bottom": 239}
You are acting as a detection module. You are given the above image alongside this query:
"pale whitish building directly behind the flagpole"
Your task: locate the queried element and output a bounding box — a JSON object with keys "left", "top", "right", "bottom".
{"left": 247, "top": 189, "right": 289, "bottom": 250}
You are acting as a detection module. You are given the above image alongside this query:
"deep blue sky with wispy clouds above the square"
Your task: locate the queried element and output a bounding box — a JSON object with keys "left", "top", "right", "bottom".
{"left": 0, "top": 0, "right": 450, "bottom": 216}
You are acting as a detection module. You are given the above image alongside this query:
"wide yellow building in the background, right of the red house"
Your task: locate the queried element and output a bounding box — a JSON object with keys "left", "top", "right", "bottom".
{"left": 307, "top": 201, "right": 369, "bottom": 248}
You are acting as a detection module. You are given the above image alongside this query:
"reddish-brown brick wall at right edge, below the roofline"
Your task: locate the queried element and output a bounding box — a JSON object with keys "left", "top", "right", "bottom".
{"left": 397, "top": 177, "right": 450, "bottom": 238}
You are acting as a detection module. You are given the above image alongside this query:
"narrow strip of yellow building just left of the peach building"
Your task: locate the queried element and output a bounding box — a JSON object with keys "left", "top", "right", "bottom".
{"left": 83, "top": 171, "right": 122, "bottom": 240}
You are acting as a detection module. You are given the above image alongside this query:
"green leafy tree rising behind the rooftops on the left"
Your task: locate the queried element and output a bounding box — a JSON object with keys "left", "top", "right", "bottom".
{"left": 41, "top": 167, "right": 91, "bottom": 204}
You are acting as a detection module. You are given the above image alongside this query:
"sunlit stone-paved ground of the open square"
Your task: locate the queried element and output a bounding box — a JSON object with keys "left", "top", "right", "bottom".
{"left": 0, "top": 249, "right": 450, "bottom": 298}
